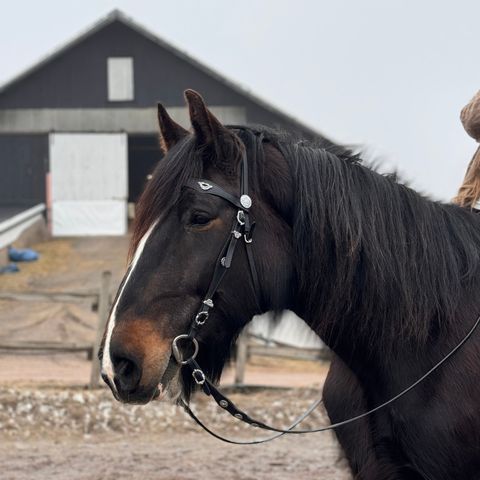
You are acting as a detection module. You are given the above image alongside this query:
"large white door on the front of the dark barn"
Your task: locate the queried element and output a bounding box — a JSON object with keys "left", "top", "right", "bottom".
{"left": 49, "top": 133, "right": 128, "bottom": 236}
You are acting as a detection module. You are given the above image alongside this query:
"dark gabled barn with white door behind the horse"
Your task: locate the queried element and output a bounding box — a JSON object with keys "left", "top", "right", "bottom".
{"left": 0, "top": 10, "right": 318, "bottom": 242}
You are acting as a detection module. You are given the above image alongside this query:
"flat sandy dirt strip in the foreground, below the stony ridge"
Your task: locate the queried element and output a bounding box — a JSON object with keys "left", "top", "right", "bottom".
{"left": 0, "top": 433, "right": 350, "bottom": 480}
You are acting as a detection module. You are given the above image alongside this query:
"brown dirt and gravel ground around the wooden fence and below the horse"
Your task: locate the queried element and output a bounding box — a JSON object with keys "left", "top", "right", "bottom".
{"left": 0, "top": 238, "right": 350, "bottom": 480}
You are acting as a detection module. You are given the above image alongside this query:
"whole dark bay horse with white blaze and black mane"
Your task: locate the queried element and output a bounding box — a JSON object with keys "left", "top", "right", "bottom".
{"left": 101, "top": 90, "right": 480, "bottom": 480}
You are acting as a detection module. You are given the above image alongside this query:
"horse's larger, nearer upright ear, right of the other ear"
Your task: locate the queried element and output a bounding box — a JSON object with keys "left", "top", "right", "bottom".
{"left": 185, "top": 89, "right": 242, "bottom": 174}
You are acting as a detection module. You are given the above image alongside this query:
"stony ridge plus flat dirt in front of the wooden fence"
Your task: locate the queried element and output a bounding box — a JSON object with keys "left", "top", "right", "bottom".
{"left": 0, "top": 388, "right": 351, "bottom": 480}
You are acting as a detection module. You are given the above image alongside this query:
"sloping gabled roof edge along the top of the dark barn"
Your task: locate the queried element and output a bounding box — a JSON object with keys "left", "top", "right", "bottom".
{"left": 0, "top": 9, "right": 322, "bottom": 137}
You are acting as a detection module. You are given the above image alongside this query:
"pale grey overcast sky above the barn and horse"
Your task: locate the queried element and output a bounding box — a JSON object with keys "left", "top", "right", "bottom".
{"left": 0, "top": 0, "right": 480, "bottom": 199}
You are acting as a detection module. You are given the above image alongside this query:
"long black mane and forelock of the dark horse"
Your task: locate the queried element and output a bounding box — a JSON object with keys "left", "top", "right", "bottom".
{"left": 132, "top": 126, "right": 480, "bottom": 348}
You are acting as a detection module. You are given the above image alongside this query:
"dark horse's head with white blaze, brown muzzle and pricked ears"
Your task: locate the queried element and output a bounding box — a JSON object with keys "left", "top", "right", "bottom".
{"left": 100, "top": 90, "right": 294, "bottom": 403}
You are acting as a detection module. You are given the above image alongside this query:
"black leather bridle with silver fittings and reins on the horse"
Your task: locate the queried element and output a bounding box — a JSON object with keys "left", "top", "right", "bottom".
{"left": 172, "top": 133, "right": 480, "bottom": 445}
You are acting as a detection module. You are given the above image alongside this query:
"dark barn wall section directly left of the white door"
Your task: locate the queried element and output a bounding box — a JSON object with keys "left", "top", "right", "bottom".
{"left": 0, "top": 135, "right": 48, "bottom": 206}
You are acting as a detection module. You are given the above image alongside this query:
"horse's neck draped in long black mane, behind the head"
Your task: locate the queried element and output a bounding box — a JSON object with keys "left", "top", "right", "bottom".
{"left": 272, "top": 142, "right": 480, "bottom": 360}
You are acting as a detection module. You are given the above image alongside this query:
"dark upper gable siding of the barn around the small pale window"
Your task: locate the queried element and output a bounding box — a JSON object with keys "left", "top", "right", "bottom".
{"left": 0, "top": 20, "right": 311, "bottom": 135}
